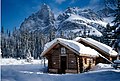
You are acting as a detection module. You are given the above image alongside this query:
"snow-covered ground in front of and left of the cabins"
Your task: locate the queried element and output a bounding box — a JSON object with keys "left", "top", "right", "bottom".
{"left": 1, "top": 59, "right": 120, "bottom": 81}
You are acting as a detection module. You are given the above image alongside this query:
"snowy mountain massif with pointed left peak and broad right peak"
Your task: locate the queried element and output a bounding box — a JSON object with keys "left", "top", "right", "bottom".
{"left": 20, "top": 4, "right": 107, "bottom": 37}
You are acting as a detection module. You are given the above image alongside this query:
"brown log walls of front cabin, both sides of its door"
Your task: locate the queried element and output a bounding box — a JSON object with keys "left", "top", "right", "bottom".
{"left": 46, "top": 45, "right": 95, "bottom": 73}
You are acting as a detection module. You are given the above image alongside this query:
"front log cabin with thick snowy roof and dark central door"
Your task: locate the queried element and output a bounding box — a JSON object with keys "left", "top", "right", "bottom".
{"left": 41, "top": 38, "right": 99, "bottom": 74}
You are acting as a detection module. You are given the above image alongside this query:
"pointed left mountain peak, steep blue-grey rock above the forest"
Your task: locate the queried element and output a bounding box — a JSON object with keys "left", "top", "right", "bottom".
{"left": 20, "top": 4, "right": 55, "bottom": 34}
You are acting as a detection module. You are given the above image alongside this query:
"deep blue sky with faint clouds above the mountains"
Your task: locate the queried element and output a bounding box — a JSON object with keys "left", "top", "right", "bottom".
{"left": 0, "top": 0, "right": 102, "bottom": 31}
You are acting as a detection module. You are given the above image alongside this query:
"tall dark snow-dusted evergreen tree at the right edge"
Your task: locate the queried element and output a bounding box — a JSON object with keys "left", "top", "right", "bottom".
{"left": 112, "top": 0, "right": 120, "bottom": 59}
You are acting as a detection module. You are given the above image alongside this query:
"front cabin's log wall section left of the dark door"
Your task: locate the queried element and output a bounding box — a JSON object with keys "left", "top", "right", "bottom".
{"left": 45, "top": 45, "right": 60, "bottom": 73}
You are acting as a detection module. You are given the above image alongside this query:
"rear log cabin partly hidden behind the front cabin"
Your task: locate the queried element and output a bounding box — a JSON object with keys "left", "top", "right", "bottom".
{"left": 73, "top": 37, "right": 118, "bottom": 64}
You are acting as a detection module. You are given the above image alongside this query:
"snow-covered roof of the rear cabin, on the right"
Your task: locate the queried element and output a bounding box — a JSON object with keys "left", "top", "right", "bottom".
{"left": 74, "top": 37, "right": 118, "bottom": 56}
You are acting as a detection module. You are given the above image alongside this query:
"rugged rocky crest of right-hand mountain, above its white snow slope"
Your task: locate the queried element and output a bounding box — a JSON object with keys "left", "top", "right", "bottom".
{"left": 57, "top": 7, "right": 102, "bottom": 21}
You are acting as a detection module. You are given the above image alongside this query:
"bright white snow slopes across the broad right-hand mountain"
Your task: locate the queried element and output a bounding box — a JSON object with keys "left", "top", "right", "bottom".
{"left": 62, "top": 15, "right": 104, "bottom": 37}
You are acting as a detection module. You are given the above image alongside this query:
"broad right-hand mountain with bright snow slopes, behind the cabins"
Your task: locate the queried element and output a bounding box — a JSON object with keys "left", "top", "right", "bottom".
{"left": 57, "top": 7, "right": 106, "bottom": 36}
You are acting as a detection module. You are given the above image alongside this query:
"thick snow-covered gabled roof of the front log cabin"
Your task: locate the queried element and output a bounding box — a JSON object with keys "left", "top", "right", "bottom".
{"left": 41, "top": 38, "right": 98, "bottom": 57}
